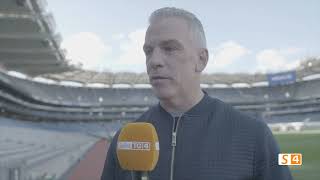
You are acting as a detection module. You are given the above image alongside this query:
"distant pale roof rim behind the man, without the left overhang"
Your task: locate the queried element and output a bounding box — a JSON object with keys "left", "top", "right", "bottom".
{"left": 43, "top": 58, "right": 320, "bottom": 85}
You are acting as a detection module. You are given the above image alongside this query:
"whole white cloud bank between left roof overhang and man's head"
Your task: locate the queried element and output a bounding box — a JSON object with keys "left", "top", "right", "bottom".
{"left": 61, "top": 28, "right": 146, "bottom": 72}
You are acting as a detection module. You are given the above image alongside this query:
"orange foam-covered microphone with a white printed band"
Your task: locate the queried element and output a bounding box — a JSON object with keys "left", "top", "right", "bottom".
{"left": 117, "top": 122, "right": 160, "bottom": 180}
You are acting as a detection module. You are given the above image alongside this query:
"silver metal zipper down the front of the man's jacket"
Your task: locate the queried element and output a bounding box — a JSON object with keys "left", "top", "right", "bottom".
{"left": 170, "top": 115, "right": 183, "bottom": 180}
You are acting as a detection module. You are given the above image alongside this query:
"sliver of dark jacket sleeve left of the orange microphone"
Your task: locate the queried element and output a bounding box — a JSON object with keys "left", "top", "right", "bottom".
{"left": 101, "top": 133, "right": 119, "bottom": 180}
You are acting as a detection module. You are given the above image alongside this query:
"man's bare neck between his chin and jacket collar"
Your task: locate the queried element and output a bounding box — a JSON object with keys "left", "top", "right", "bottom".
{"left": 160, "top": 89, "right": 204, "bottom": 113}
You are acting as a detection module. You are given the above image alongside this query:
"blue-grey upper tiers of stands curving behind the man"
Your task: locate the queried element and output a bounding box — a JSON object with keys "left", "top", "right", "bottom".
{"left": 0, "top": 73, "right": 320, "bottom": 120}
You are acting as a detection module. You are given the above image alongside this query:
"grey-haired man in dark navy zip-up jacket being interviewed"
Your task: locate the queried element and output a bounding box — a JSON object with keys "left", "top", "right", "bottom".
{"left": 101, "top": 8, "right": 292, "bottom": 180}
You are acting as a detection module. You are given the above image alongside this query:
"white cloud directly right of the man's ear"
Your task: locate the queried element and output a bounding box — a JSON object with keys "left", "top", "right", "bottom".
{"left": 205, "top": 41, "right": 251, "bottom": 73}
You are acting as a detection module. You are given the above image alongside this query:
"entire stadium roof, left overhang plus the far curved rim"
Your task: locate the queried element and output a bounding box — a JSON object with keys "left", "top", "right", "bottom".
{"left": 0, "top": 0, "right": 320, "bottom": 87}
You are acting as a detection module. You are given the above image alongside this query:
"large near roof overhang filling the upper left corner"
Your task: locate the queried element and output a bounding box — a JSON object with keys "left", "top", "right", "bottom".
{"left": 0, "top": 0, "right": 75, "bottom": 76}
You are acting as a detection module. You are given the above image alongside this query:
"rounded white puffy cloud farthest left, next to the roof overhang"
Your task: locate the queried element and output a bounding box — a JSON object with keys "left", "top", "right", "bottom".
{"left": 61, "top": 32, "right": 112, "bottom": 70}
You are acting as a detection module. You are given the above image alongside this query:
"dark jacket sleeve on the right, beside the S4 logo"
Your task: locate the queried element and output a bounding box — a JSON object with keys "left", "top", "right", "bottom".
{"left": 254, "top": 121, "right": 292, "bottom": 180}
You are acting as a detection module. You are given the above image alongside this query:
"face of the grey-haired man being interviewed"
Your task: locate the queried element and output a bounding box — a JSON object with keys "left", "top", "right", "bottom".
{"left": 143, "top": 18, "right": 197, "bottom": 99}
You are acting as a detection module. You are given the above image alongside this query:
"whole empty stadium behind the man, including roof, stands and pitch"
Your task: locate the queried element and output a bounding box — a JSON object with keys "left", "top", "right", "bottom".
{"left": 0, "top": 0, "right": 320, "bottom": 180}
